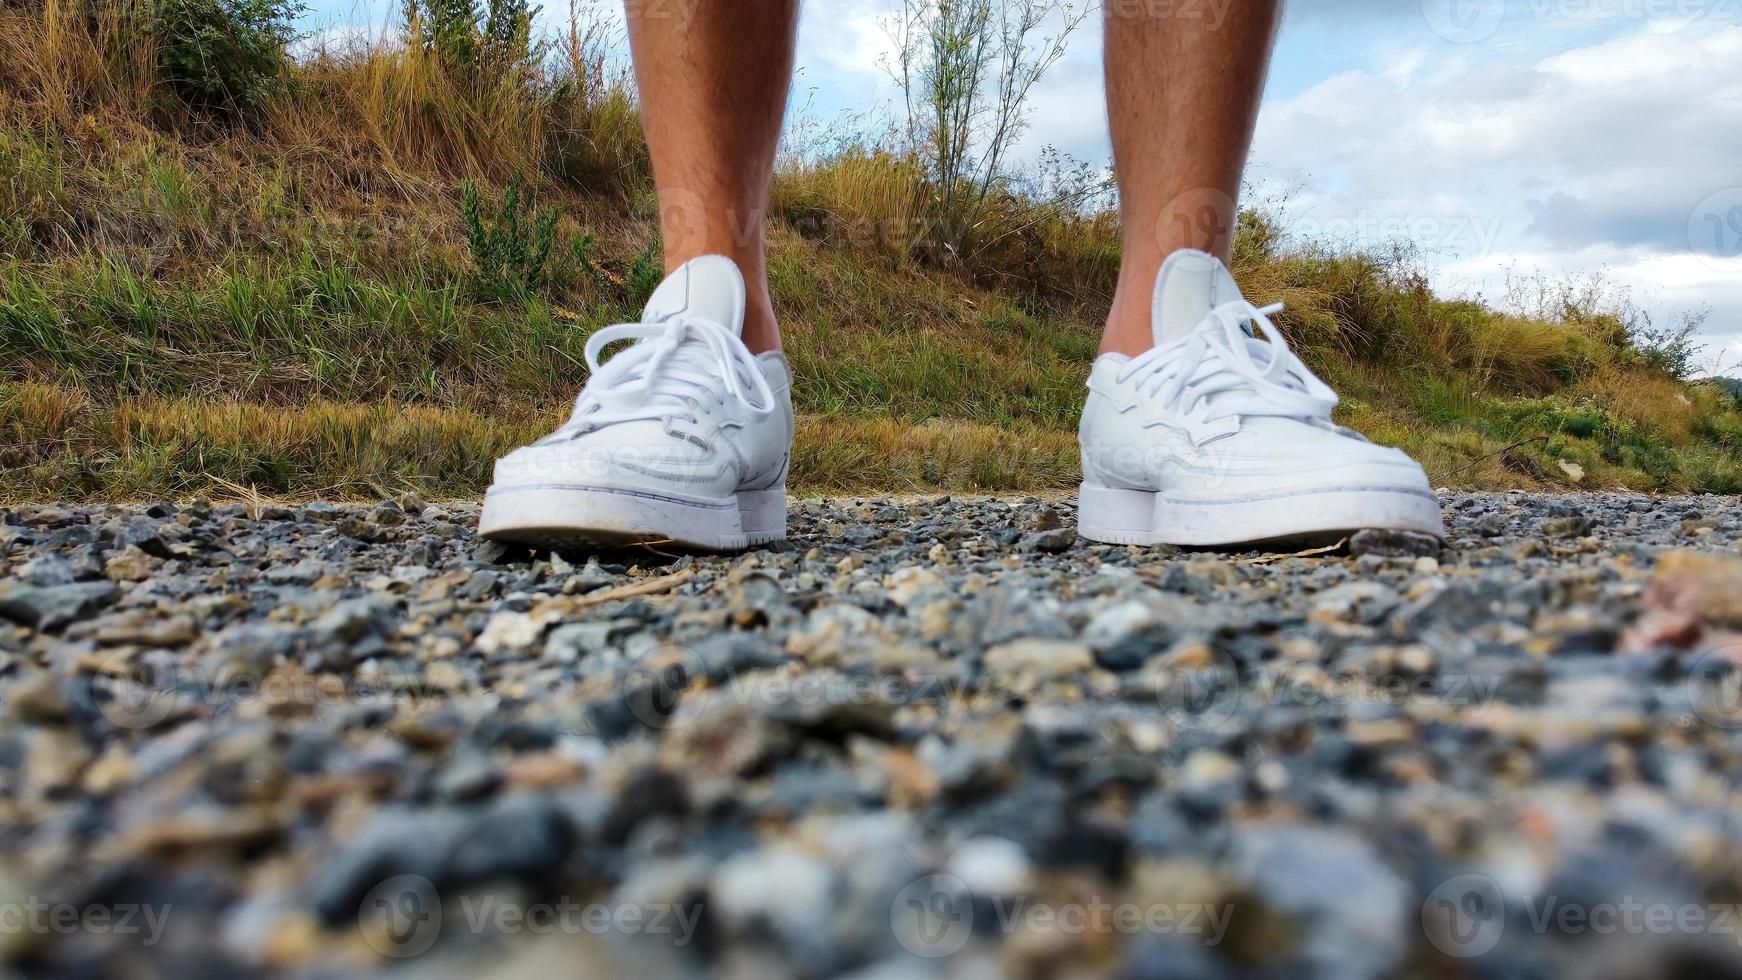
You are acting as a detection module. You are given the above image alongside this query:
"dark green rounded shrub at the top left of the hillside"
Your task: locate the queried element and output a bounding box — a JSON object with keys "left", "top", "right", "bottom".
{"left": 146, "top": 0, "right": 303, "bottom": 118}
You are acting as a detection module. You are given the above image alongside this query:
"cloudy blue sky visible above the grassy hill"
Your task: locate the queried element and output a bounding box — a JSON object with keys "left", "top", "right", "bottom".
{"left": 303, "top": 0, "right": 1742, "bottom": 374}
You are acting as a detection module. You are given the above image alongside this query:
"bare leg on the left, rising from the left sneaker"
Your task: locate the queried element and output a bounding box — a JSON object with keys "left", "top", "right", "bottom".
{"left": 625, "top": 0, "right": 798, "bottom": 353}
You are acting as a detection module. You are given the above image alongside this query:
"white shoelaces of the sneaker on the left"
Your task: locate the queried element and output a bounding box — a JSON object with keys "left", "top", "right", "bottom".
{"left": 557, "top": 317, "right": 775, "bottom": 437}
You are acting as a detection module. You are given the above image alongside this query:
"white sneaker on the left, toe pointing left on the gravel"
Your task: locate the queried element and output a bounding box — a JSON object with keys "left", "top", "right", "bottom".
{"left": 479, "top": 256, "right": 793, "bottom": 550}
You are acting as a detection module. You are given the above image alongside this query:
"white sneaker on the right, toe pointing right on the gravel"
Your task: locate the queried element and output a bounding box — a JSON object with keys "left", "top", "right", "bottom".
{"left": 1078, "top": 251, "right": 1444, "bottom": 545}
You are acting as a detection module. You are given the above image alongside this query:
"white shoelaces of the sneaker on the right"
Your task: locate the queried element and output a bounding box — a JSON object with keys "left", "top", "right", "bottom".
{"left": 1117, "top": 299, "right": 1338, "bottom": 421}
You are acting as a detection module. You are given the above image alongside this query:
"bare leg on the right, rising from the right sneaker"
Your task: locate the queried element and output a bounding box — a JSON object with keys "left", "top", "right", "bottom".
{"left": 1101, "top": 0, "right": 1282, "bottom": 355}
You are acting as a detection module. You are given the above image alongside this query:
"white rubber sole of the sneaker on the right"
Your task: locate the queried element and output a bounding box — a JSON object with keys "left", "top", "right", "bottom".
{"left": 1077, "top": 484, "right": 1446, "bottom": 547}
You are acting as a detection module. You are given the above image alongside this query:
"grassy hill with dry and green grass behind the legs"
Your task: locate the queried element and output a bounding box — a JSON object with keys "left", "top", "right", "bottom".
{"left": 0, "top": 0, "right": 1742, "bottom": 500}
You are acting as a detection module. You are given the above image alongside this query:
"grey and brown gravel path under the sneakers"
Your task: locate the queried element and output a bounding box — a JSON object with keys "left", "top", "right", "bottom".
{"left": 0, "top": 494, "right": 1742, "bottom": 980}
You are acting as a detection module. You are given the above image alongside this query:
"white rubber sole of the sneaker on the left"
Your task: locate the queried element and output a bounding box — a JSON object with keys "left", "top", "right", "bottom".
{"left": 477, "top": 484, "right": 786, "bottom": 552}
